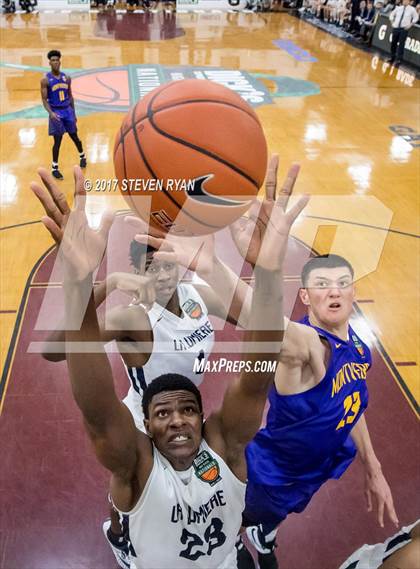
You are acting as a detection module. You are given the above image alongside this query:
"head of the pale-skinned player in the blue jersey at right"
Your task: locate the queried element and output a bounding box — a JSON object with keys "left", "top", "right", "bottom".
{"left": 300, "top": 255, "right": 354, "bottom": 327}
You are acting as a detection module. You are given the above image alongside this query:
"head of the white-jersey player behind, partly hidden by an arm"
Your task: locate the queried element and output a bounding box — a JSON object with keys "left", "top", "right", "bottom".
{"left": 130, "top": 240, "right": 179, "bottom": 306}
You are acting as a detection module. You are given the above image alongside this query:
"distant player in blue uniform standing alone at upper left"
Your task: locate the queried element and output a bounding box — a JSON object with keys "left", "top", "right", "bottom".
{"left": 41, "top": 49, "right": 86, "bottom": 180}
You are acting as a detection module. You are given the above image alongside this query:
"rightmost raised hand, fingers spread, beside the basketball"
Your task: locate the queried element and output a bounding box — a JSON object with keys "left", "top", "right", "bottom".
{"left": 230, "top": 154, "right": 309, "bottom": 270}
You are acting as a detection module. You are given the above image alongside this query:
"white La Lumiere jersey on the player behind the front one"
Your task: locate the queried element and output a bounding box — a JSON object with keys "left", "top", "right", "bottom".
{"left": 124, "top": 284, "right": 214, "bottom": 430}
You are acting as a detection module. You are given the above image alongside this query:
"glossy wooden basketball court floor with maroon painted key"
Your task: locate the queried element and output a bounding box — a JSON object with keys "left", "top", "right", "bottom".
{"left": 0, "top": 5, "right": 420, "bottom": 569}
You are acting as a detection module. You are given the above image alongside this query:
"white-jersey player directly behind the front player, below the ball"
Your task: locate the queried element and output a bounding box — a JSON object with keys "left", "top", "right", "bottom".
{"left": 43, "top": 236, "right": 240, "bottom": 418}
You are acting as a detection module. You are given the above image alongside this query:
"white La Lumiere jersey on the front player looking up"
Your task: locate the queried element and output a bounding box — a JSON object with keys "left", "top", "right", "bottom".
{"left": 121, "top": 439, "right": 246, "bottom": 569}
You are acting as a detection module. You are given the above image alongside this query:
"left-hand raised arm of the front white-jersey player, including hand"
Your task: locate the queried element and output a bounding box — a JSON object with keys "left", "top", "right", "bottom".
{"left": 31, "top": 167, "right": 152, "bottom": 508}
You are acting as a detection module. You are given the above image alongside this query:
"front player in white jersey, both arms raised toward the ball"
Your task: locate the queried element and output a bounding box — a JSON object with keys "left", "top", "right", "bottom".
{"left": 31, "top": 159, "right": 307, "bottom": 569}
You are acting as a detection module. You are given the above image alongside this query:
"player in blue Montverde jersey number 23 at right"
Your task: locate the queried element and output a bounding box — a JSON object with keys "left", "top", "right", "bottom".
{"left": 239, "top": 255, "right": 398, "bottom": 569}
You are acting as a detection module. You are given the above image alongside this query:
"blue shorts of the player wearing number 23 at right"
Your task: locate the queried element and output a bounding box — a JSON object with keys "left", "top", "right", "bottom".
{"left": 243, "top": 480, "right": 326, "bottom": 533}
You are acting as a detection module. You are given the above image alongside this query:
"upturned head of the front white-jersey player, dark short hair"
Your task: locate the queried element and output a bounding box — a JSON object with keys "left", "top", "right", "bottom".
{"left": 143, "top": 373, "right": 203, "bottom": 467}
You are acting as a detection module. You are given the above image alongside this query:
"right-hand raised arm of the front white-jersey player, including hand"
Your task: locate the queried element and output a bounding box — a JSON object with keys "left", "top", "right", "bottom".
{"left": 205, "top": 157, "right": 308, "bottom": 480}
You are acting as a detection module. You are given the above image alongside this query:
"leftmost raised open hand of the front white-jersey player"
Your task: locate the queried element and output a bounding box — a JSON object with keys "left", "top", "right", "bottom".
{"left": 30, "top": 166, "right": 114, "bottom": 281}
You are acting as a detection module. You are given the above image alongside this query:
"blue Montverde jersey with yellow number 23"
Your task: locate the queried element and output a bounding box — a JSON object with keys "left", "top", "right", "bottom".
{"left": 246, "top": 316, "right": 372, "bottom": 486}
